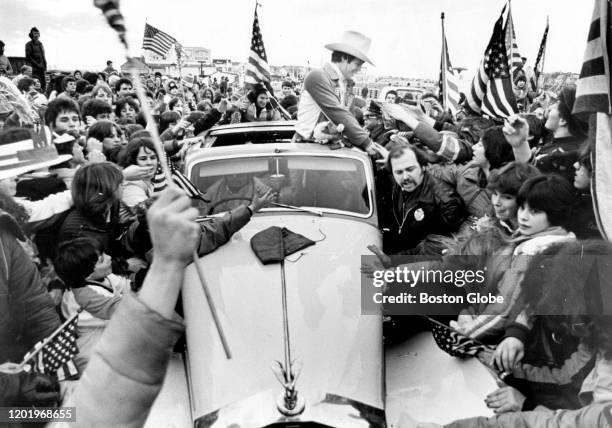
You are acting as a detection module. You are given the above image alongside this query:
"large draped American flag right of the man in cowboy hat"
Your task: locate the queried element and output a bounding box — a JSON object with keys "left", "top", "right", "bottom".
{"left": 464, "top": 7, "right": 518, "bottom": 118}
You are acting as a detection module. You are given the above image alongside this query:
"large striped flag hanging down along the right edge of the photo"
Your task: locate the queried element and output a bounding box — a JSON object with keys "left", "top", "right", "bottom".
{"left": 572, "top": 0, "right": 612, "bottom": 240}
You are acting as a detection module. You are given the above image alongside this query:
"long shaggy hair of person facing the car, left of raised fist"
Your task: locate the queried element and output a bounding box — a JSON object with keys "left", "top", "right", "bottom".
{"left": 71, "top": 162, "right": 123, "bottom": 221}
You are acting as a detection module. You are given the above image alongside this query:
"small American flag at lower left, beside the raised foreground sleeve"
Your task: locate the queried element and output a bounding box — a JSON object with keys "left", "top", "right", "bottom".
{"left": 22, "top": 311, "right": 81, "bottom": 380}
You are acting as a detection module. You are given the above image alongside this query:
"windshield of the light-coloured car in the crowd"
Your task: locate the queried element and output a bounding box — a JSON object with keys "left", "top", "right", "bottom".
{"left": 191, "top": 155, "right": 371, "bottom": 215}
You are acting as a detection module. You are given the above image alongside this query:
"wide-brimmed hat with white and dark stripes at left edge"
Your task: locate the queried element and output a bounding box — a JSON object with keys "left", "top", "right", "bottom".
{"left": 0, "top": 129, "right": 72, "bottom": 180}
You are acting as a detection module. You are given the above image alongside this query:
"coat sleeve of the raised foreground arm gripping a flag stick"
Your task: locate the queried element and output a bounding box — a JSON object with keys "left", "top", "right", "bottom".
{"left": 51, "top": 293, "right": 184, "bottom": 428}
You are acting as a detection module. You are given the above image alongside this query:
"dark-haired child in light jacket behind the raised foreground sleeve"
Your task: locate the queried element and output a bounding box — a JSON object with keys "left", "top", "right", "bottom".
{"left": 54, "top": 238, "right": 129, "bottom": 371}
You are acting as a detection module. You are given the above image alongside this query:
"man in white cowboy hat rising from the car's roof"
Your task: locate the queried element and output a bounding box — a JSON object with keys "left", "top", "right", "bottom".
{"left": 295, "top": 31, "right": 378, "bottom": 155}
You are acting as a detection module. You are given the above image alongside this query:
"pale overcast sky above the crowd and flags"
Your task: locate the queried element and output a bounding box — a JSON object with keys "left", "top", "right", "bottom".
{"left": 0, "top": 0, "right": 593, "bottom": 79}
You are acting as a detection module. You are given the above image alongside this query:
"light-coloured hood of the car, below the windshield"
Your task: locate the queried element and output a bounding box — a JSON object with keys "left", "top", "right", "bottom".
{"left": 183, "top": 213, "right": 383, "bottom": 419}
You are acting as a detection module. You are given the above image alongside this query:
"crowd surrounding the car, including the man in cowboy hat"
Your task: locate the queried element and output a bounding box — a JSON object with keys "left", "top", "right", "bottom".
{"left": 0, "top": 28, "right": 612, "bottom": 426}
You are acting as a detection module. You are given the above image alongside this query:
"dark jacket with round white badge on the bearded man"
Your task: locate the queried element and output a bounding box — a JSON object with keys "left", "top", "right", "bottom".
{"left": 385, "top": 171, "right": 466, "bottom": 254}
